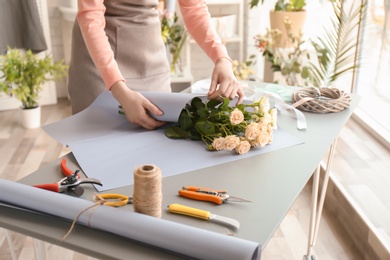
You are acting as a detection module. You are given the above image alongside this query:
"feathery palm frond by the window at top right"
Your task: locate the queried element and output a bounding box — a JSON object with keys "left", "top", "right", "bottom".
{"left": 310, "top": 1, "right": 366, "bottom": 87}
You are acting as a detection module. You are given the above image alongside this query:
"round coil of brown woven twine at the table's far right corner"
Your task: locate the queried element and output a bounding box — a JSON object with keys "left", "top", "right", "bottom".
{"left": 292, "top": 88, "right": 351, "bottom": 113}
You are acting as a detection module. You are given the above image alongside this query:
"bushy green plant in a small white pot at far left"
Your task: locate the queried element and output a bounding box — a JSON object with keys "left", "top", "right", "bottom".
{"left": 0, "top": 47, "right": 67, "bottom": 128}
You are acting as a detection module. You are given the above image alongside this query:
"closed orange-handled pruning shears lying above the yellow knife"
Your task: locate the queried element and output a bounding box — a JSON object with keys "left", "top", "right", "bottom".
{"left": 179, "top": 186, "right": 250, "bottom": 204}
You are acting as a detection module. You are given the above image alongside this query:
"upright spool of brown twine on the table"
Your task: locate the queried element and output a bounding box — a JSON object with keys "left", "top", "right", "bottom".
{"left": 133, "top": 165, "right": 162, "bottom": 218}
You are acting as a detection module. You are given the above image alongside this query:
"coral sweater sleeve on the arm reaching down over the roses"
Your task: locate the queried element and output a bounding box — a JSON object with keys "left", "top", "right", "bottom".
{"left": 179, "top": 0, "right": 232, "bottom": 63}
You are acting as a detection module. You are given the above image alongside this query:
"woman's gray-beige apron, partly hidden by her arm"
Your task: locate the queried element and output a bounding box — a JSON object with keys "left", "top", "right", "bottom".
{"left": 68, "top": 0, "right": 171, "bottom": 114}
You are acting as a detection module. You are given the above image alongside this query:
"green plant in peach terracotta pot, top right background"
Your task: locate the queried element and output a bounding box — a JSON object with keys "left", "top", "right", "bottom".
{"left": 249, "top": 0, "right": 306, "bottom": 47}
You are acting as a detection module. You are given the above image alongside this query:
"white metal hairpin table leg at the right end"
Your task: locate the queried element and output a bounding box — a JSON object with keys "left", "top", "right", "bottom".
{"left": 304, "top": 138, "right": 337, "bottom": 260}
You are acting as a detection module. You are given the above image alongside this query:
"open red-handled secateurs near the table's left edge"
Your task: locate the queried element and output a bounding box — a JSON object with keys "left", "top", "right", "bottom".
{"left": 34, "top": 159, "right": 103, "bottom": 196}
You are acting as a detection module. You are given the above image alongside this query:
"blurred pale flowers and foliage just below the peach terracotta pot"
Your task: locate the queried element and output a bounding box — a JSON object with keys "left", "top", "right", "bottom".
{"left": 255, "top": 17, "right": 310, "bottom": 86}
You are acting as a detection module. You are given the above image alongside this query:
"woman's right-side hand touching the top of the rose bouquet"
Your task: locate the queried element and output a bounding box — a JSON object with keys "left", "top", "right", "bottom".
{"left": 207, "top": 58, "right": 244, "bottom": 104}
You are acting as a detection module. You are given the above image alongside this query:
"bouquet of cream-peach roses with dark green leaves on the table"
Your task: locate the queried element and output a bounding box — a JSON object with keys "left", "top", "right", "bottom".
{"left": 165, "top": 97, "right": 277, "bottom": 154}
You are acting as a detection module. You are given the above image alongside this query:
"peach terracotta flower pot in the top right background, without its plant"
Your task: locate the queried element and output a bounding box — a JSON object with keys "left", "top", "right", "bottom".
{"left": 269, "top": 11, "right": 306, "bottom": 48}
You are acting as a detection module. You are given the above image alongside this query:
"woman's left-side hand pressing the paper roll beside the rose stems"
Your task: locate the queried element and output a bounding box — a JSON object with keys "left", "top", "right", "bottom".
{"left": 111, "top": 81, "right": 165, "bottom": 130}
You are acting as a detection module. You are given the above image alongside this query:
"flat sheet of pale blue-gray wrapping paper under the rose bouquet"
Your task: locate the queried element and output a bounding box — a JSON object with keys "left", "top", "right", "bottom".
{"left": 44, "top": 92, "right": 302, "bottom": 191}
